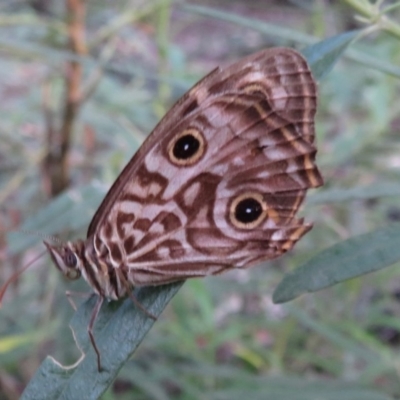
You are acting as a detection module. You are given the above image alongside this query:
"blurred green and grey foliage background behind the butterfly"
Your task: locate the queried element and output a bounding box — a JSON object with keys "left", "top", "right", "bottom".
{"left": 0, "top": 0, "right": 400, "bottom": 400}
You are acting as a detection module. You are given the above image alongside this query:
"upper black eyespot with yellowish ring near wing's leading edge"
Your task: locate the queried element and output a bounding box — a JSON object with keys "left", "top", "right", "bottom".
{"left": 168, "top": 128, "right": 205, "bottom": 166}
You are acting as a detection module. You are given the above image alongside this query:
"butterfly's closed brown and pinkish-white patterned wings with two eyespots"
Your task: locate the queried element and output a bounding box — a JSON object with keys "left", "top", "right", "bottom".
{"left": 88, "top": 48, "right": 322, "bottom": 285}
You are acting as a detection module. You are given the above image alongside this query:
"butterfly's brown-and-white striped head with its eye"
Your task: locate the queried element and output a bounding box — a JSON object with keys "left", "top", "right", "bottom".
{"left": 44, "top": 242, "right": 82, "bottom": 280}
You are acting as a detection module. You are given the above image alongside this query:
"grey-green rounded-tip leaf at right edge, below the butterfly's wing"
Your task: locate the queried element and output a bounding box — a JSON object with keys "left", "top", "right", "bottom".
{"left": 273, "top": 224, "right": 400, "bottom": 303}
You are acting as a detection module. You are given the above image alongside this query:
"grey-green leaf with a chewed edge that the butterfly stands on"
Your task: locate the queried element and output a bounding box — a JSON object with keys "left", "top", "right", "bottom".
{"left": 21, "top": 282, "right": 183, "bottom": 400}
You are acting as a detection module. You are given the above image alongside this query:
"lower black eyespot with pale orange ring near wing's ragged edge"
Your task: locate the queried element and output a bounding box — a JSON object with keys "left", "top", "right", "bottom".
{"left": 229, "top": 192, "right": 267, "bottom": 229}
